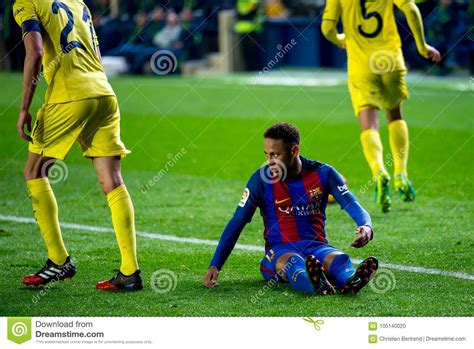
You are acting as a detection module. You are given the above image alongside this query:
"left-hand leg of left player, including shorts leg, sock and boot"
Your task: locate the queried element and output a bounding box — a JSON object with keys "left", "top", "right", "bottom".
{"left": 23, "top": 101, "right": 86, "bottom": 285}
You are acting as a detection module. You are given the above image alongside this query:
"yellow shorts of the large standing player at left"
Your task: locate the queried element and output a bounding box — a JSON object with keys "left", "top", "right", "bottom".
{"left": 28, "top": 96, "right": 130, "bottom": 160}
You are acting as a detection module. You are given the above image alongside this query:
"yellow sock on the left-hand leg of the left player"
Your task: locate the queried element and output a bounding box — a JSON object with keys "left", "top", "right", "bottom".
{"left": 26, "top": 178, "right": 68, "bottom": 264}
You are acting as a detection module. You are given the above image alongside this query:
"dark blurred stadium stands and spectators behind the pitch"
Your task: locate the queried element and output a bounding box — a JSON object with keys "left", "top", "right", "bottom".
{"left": 0, "top": 0, "right": 474, "bottom": 75}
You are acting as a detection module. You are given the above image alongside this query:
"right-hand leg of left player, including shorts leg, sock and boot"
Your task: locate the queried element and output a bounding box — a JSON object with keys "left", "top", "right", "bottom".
{"left": 78, "top": 96, "right": 139, "bottom": 291}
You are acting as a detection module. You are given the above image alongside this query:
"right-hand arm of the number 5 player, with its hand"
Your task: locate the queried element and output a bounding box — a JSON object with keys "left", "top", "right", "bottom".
{"left": 395, "top": 0, "right": 441, "bottom": 62}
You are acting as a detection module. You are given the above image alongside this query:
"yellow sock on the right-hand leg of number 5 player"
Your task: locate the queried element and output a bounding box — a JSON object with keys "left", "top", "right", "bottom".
{"left": 388, "top": 120, "right": 409, "bottom": 176}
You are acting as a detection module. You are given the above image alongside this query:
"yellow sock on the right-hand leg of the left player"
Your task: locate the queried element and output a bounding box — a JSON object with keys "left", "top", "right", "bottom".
{"left": 107, "top": 184, "right": 138, "bottom": 275}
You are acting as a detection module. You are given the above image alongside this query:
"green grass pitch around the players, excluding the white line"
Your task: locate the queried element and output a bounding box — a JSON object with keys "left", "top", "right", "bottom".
{"left": 0, "top": 73, "right": 474, "bottom": 316}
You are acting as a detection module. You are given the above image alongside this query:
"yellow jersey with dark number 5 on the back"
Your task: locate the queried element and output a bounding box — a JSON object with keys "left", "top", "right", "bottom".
{"left": 323, "top": 0, "right": 413, "bottom": 76}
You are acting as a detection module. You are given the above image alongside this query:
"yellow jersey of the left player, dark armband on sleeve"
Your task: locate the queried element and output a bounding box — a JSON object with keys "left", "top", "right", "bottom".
{"left": 13, "top": 0, "right": 115, "bottom": 104}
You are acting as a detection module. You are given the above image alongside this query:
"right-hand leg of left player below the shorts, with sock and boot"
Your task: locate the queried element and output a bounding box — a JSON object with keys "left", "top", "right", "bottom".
{"left": 92, "top": 156, "right": 143, "bottom": 291}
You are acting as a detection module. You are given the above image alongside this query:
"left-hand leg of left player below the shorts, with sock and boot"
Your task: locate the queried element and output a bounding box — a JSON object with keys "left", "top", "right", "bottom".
{"left": 23, "top": 152, "right": 76, "bottom": 286}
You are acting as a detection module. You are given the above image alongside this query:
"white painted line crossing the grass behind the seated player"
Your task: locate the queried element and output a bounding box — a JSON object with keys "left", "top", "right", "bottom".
{"left": 0, "top": 215, "right": 474, "bottom": 280}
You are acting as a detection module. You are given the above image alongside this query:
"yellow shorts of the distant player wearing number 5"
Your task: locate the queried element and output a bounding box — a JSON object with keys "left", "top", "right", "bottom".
{"left": 349, "top": 70, "right": 408, "bottom": 116}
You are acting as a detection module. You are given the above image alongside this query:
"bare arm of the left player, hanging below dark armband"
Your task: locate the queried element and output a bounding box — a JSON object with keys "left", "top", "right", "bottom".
{"left": 16, "top": 31, "right": 43, "bottom": 142}
